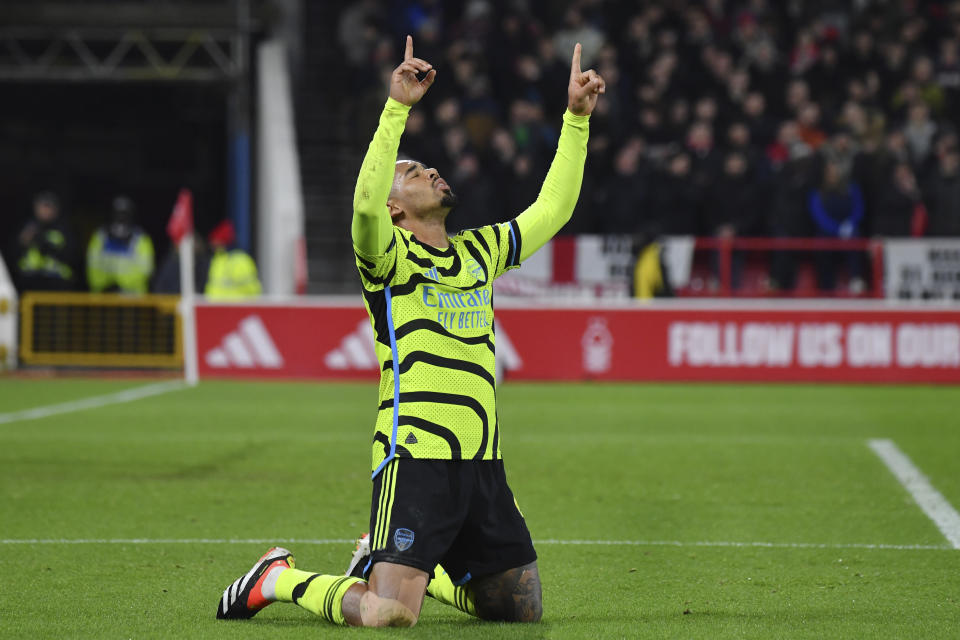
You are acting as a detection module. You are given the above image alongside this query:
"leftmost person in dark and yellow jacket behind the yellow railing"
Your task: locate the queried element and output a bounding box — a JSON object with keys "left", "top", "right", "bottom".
{"left": 12, "top": 191, "right": 75, "bottom": 291}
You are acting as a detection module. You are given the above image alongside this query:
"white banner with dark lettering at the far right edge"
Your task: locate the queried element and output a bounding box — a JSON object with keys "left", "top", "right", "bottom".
{"left": 883, "top": 238, "right": 960, "bottom": 300}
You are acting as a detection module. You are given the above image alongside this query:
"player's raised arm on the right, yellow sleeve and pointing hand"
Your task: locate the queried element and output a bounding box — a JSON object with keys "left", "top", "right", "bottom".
{"left": 517, "top": 43, "right": 606, "bottom": 262}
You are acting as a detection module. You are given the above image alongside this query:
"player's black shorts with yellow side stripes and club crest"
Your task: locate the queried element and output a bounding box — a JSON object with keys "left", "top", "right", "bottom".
{"left": 364, "top": 458, "right": 537, "bottom": 584}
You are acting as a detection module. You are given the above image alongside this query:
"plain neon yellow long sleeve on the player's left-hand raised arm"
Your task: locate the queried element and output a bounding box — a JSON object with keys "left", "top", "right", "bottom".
{"left": 350, "top": 98, "right": 410, "bottom": 262}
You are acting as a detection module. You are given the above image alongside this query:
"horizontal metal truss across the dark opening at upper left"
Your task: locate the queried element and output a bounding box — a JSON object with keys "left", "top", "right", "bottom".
{"left": 0, "top": 26, "right": 248, "bottom": 82}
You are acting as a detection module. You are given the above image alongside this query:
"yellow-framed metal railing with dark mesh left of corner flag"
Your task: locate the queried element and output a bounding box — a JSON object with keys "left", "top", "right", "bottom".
{"left": 20, "top": 292, "right": 183, "bottom": 368}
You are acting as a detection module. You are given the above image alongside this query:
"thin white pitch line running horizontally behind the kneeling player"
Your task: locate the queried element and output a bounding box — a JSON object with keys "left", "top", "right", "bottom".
{"left": 0, "top": 538, "right": 952, "bottom": 551}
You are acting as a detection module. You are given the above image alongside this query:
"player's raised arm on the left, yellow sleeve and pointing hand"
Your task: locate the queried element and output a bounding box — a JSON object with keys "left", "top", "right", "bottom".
{"left": 351, "top": 36, "right": 437, "bottom": 256}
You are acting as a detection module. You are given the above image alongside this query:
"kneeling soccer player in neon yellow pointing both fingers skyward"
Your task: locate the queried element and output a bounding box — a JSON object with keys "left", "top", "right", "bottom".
{"left": 217, "top": 36, "right": 605, "bottom": 627}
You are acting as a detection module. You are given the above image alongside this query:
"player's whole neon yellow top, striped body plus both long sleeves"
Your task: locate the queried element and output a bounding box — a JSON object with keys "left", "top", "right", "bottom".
{"left": 352, "top": 99, "right": 588, "bottom": 476}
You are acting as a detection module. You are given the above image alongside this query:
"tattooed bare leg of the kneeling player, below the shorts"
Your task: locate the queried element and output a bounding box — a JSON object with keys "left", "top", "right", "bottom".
{"left": 470, "top": 562, "right": 543, "bottom": 622}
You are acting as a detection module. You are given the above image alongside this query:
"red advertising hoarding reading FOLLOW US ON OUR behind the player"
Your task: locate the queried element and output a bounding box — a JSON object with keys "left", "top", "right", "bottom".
{"left": 197, "top": 301, "right": 960, "bottom": 383}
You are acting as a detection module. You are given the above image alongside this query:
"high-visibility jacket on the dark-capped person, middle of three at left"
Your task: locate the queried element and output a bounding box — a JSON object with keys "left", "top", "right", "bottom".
{"left": 87, "top": 229, "right": 154, "bottom": 294}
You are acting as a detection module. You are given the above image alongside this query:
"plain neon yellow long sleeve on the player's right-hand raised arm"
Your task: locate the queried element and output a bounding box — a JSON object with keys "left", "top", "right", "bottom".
{"left": 510, "top": 110, "right": 590, "bottom": 264}
